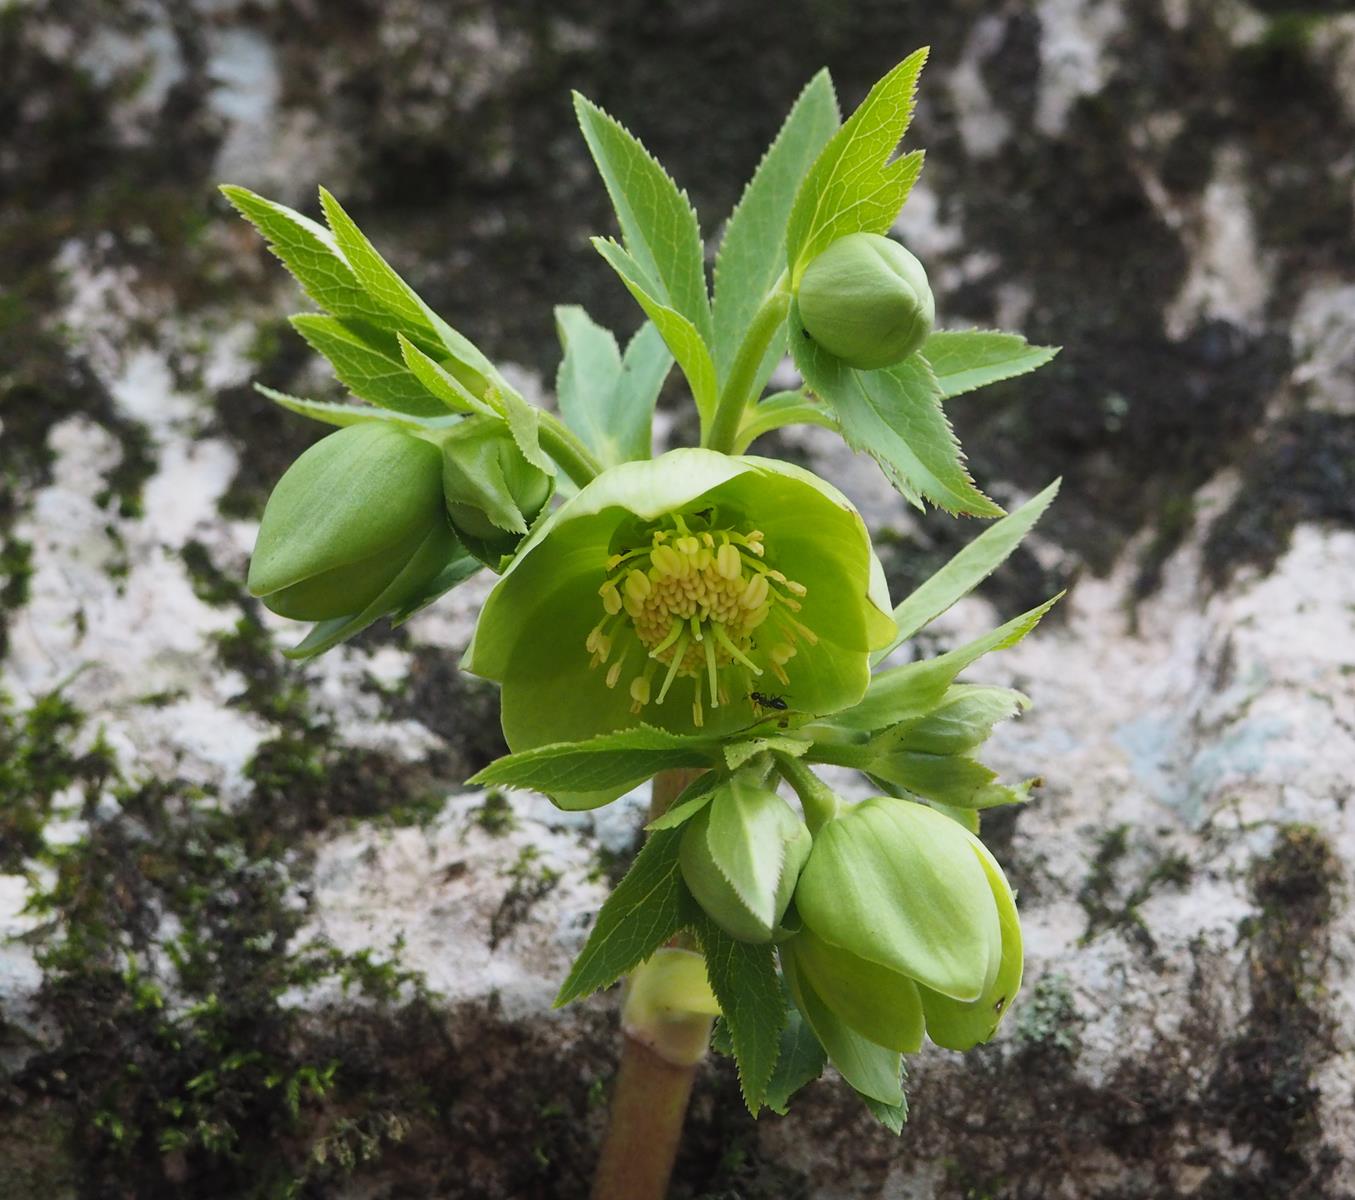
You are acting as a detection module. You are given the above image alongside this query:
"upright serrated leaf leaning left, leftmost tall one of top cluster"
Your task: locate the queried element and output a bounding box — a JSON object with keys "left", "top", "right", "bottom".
{"left": 575, "top": 92, "right": 711, "bottom": 344}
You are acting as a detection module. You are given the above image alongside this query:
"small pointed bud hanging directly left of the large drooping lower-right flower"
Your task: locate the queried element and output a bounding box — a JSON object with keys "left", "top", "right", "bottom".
{"left": 678, "top": 772, "right": 812, "bottom": 943}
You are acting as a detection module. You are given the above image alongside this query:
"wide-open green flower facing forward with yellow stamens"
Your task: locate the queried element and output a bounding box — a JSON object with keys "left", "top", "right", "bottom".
{"left": 466, "top": 450, "right": 894, "bottom": 752}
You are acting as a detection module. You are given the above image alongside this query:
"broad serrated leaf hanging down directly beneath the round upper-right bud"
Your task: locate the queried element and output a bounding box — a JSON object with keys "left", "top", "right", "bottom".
{"left": 790, "top": 303, "right": 1003, "bottom": 516}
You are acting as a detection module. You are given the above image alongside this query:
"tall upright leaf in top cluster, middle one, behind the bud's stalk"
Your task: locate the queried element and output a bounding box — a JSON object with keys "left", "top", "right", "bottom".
{"left": 713, "top": 70, "right": 837, "bottom": 381}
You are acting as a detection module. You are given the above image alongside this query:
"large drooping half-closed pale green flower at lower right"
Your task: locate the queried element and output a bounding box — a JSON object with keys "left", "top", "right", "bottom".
{"left": 794, "top": 796, "right": 1022, "bottom": 1050}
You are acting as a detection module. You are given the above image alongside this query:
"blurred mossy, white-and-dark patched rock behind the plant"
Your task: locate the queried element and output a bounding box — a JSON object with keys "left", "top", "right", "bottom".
{"left": 0, "top": 0, "right": 1355, "bottom": 1200}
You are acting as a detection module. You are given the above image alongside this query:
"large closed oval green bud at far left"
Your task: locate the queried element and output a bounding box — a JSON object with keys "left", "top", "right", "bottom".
{"left": 248, "top": 421, "right": 459, "bottom": 622}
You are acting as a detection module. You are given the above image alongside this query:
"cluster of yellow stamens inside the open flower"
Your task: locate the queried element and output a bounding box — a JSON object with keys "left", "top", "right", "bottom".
{"left": 585, "top": 513, "right": 818, "bottom": 727}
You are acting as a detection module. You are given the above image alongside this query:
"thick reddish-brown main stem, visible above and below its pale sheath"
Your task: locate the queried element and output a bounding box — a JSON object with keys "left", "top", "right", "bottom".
{"left": 592, "top": 768, "right": 701, "bottom": 1200}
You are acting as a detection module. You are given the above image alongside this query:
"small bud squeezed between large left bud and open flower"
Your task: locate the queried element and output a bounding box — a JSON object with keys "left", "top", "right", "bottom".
{"left": 439, "top": 416, "right": 554, "bottom": 566}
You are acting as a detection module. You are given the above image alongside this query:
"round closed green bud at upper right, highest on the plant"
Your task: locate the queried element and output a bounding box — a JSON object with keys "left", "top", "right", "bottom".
{"left": 798, "top": 233, "right": 936, "bottom": 371}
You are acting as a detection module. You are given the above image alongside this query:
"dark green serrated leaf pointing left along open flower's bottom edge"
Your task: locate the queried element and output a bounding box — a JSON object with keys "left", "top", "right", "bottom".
{"left": 469, "top": 725, "right": 720, "bottom": 792}
